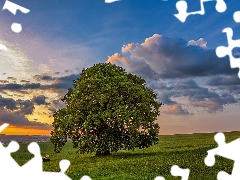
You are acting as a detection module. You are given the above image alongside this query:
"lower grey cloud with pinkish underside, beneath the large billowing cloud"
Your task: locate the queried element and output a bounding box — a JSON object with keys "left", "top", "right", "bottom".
{"left": 149, "top": 79, "right": 237, "bottom": 114}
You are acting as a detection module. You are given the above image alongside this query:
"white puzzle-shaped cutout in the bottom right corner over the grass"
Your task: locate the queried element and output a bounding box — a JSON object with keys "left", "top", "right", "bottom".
{"left": 204, "top": 133, "right": 240, "bottom": 180}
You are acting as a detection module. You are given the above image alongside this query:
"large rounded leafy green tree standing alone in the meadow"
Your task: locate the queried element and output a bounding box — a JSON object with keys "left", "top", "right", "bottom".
{"left": 51, "top": 63, "right": 162, "bottom": 155}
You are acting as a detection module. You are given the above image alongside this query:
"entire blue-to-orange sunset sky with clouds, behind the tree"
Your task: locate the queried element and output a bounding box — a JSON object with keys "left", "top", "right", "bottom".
{"left": 0, "top": 0, "right": 240, "bottom": 135}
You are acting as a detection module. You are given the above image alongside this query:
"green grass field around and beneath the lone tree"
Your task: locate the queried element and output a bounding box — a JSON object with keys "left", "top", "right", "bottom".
{"left": 9, "top": 132, "right": 240, "bottom": 180}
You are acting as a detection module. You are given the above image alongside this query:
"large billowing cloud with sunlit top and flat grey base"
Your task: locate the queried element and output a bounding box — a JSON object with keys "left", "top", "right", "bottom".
{"left": 107, "top": 34, "right": 238, "bottom": 79}
